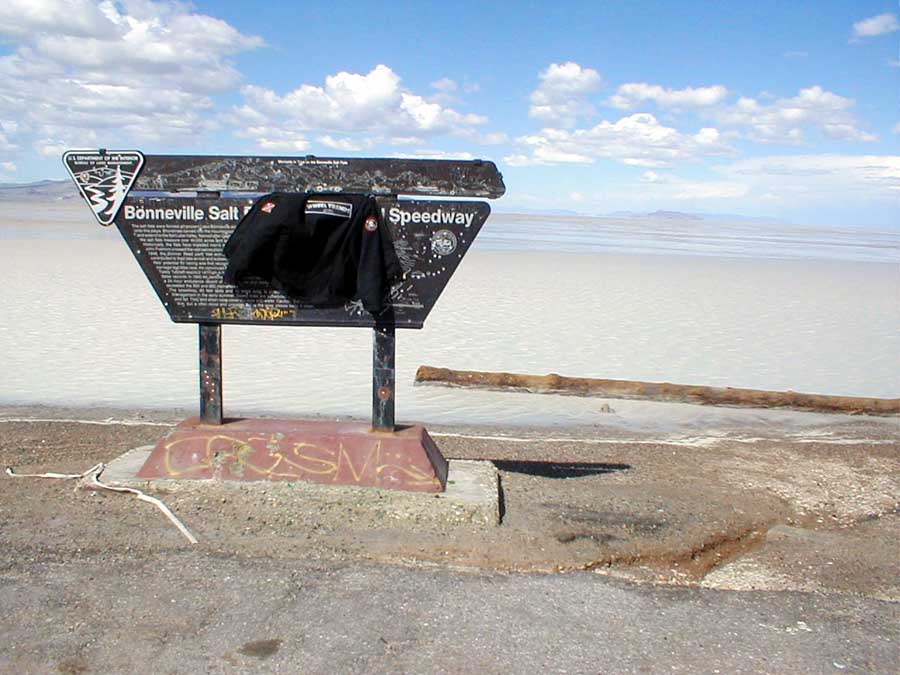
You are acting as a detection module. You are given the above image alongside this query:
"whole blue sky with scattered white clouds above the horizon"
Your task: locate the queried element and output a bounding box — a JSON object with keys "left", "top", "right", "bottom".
{"left": 0, "top": 0, "right": 900, "bottom": 227}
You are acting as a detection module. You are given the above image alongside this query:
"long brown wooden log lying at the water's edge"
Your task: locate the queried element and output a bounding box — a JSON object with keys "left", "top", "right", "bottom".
{"left": 415, "top": 366, "right": 900, "bottom": 416}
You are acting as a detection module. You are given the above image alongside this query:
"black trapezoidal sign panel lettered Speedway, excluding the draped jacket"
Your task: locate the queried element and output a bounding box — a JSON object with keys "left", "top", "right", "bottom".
{"left": 116, "top": 197, "right": 490, "bottom": 328}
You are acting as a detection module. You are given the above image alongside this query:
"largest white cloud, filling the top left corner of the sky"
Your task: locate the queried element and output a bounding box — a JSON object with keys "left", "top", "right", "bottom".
{"left": 0, "top": 0, "right": 262, "bottom": 155}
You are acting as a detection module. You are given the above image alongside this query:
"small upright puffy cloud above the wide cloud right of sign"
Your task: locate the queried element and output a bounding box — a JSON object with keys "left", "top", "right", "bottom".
{"left": 528, "top": 61, "right": 603, "bottom": 127}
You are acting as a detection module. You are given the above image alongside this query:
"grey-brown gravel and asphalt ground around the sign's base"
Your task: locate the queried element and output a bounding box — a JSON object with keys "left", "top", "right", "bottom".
{"left": 0, "top": 407, "right": 900, "bottom": 672}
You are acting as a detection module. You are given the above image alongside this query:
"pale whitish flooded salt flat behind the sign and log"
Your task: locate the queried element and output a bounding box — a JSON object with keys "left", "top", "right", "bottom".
{"left": 0, "top": 217, "right": 900, "bottom": 424}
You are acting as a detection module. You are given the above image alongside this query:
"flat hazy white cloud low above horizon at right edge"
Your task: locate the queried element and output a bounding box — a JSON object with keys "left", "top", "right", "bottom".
{"left": 717, "top": 155, "right": 900, "bottom": 202}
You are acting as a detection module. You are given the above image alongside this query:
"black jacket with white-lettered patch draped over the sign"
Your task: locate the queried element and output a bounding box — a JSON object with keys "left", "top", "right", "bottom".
{"left": 224, "top": 192, "right": 403, "bottom": 314}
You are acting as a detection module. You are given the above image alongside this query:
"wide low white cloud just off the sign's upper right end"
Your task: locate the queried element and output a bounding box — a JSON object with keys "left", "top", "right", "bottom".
{"left": 505, "top": 113, "right": 731, "bottom": 168}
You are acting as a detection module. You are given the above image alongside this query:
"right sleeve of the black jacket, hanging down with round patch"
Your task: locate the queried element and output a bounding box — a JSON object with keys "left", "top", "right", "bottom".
{"left": 357, "top": 197, "right": 403, "bottom": 314}
